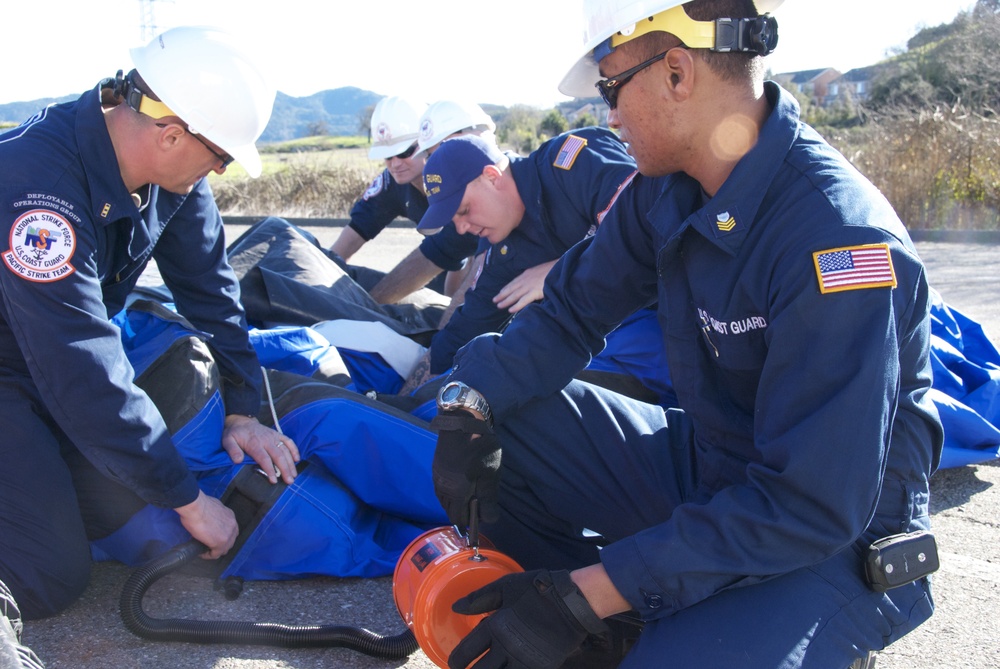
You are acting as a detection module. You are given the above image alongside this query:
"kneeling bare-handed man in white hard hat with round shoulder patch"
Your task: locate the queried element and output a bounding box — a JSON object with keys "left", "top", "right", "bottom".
{"left": 0, "top": 28, "right": 298, "bottom": 618}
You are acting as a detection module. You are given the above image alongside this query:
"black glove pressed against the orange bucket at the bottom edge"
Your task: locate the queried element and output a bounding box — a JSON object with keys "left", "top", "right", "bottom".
{"left": 448, "top": 569, "right": 608, "bottom": 669}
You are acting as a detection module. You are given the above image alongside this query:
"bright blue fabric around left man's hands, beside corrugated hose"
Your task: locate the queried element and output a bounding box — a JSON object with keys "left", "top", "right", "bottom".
{"left": 91, "top": 308, "right": 447, "bottom": 580}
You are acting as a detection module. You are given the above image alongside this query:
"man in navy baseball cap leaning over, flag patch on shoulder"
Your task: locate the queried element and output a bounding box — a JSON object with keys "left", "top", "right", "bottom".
{"left": 406, "top": 128, "right": 635, "bottom": 380}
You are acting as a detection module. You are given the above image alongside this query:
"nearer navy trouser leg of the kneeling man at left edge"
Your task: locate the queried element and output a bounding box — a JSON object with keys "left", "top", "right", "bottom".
{"left": 0, "top": 377, "right": 90, "bottom": 619}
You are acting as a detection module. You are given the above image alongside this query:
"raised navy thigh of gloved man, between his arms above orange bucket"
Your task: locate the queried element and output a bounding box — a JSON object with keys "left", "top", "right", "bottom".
{"left": 482, "top": 381, "right": 693, "bottom": 569}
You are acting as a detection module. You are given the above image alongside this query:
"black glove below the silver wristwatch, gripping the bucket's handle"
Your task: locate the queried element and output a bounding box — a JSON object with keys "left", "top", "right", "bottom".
{"left": 431, "top": 411, "right": 500, "bottom": 530}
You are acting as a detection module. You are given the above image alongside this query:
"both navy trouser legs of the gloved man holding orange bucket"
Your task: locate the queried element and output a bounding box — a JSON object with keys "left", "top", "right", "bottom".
{"left": 483, "top": 382, "right": 932, "bottom": 669}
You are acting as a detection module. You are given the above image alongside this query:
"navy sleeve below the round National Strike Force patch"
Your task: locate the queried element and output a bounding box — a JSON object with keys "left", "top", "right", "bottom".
{"left": 0, "top": 202, "right": 198, "bottom": 508}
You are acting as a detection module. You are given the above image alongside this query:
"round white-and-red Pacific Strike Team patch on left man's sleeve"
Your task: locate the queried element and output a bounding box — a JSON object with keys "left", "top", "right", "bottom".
{"left": 3, "top": 209, "right": 76, "bottom": 283}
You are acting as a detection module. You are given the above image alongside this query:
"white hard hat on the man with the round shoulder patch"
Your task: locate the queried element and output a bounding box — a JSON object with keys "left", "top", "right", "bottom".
{"left": 130, "top": 27, "right": 276, "bottom": 177}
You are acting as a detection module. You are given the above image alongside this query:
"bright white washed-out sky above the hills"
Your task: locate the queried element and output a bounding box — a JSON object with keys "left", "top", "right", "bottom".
{"left": 0, "top": 0, "right": 975, "bottom": 107}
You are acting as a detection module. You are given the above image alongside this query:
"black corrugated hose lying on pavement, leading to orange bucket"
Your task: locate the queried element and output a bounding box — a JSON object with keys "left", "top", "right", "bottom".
{"left": 120, "top": 541, "right": 419, "bottom": 660}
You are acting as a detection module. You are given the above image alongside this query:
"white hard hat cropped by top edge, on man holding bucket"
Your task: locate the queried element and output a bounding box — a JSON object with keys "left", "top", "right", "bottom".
{"left": 559, "top": 0, "right": 784, "bottom": 97}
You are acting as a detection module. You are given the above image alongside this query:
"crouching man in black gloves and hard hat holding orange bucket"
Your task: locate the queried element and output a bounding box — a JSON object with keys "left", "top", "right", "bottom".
{"left": 434, "top": 0, "right": 942, "bottom": 669}
